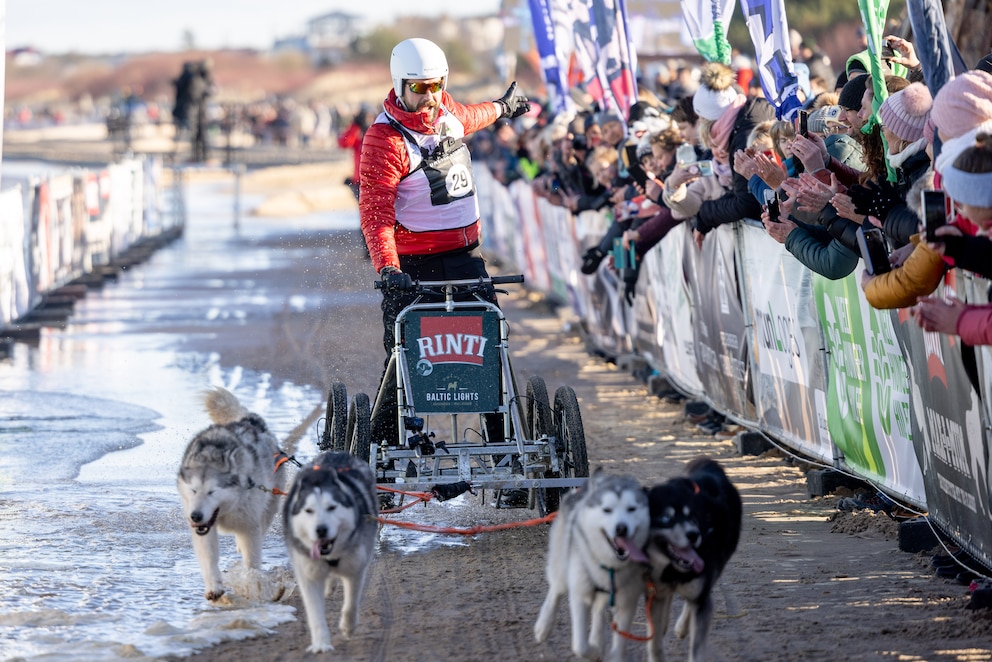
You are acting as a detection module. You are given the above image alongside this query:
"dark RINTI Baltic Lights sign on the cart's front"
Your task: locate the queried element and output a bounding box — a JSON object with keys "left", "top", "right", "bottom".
{"left": 403, "top": 310, "right": 501, "bottom": 414}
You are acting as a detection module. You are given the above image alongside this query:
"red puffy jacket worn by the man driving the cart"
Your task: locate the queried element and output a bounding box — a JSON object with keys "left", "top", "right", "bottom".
{"left": 358, "top": 91, "right": 499, "bottom": 272}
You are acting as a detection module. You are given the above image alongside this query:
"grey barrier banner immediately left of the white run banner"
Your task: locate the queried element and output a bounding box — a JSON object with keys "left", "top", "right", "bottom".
{"left": 683, "top": 224, "right": 755, "bottom": 422}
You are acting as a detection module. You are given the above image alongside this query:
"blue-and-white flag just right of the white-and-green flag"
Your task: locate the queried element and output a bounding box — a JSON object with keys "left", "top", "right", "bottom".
{"left": 741, "top": 0, "right": 803, "bottom": 120}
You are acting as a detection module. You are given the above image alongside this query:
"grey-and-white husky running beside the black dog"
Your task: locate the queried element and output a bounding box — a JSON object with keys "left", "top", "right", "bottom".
{"left": 534, "top": 468, "right": 650, "bottom": 659}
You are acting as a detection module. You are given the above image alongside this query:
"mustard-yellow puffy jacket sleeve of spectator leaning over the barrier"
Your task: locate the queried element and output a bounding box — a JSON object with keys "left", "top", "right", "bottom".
{"left": 864, "top": 235, "right": 947, "bottom": 310}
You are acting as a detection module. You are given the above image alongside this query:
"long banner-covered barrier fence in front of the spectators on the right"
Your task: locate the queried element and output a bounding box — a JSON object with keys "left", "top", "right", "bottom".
{"left": 476, "top": 164, "right": 992, "bottom": 567}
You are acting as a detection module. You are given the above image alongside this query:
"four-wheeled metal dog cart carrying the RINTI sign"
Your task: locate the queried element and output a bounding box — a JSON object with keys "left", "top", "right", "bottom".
{"left": 320, "top": 276, "right": 589, "bottom": 516}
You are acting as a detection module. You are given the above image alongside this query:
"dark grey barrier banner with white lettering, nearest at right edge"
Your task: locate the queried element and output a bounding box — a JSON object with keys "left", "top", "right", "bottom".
{"left": 892, "top": 271, "right": 992, "bottom": 559}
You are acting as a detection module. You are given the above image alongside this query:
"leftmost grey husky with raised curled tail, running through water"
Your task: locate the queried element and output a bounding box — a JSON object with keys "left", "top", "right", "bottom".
{"left": 176, "top": 388, "right": 282, "bottom": 601}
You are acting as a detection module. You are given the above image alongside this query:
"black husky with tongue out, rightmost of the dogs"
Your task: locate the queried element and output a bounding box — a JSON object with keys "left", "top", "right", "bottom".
{"left": 645, "top": 457, "right": 742, "bottom": 662}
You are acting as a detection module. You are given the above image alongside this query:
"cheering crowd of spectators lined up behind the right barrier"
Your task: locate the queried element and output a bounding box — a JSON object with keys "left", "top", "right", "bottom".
{"left": 464, "top": 35, "right": 992, "bottom": 356}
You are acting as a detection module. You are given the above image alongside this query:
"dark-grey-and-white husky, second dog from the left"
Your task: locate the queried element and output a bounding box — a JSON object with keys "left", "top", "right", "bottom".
{"left": 283, "top": 452, "right": 379, "bottom": 653}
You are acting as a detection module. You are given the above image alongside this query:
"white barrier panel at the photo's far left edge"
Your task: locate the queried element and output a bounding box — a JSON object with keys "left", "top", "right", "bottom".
{"left": 0, "top": 186, "right": 31, "bottom": 326}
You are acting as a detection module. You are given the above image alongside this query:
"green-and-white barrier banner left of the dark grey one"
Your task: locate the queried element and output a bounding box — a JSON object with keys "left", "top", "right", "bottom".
{"left": 813, "top": 265, "right": 926, "bottom": 506}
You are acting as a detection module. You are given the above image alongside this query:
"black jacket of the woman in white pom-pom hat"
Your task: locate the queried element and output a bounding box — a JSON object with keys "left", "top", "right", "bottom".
{"left": 694, "top": 97, "right": 775, "bottom": 234}
